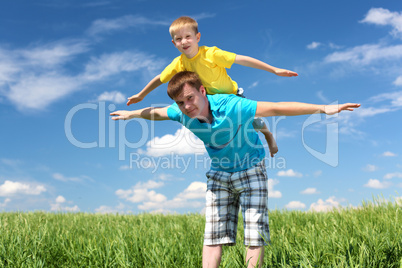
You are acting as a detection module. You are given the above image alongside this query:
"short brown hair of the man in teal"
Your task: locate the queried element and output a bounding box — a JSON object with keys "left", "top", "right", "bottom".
{"left": 168, "top": 71, "right": 202, "bottom": 100}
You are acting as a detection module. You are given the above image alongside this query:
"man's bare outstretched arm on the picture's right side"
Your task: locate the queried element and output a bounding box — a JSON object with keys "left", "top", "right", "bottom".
{"left": 255, "top": 101, "right": 360, "bottom": 117}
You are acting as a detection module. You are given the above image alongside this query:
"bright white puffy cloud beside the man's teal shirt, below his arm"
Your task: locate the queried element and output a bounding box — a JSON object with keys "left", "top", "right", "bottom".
{"left": 138, "top": 127, "right": 206, "bottom": 157}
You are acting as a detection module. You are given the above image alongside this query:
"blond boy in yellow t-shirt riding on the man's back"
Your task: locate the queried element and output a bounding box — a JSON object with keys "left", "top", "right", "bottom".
{"left": 127, "top": 16, "right": 297, "bottom": 157}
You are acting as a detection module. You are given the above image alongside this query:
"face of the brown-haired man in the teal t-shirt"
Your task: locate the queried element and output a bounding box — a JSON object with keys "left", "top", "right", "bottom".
{"left": 174, "top": 84, "right": 209, "bottom": 120}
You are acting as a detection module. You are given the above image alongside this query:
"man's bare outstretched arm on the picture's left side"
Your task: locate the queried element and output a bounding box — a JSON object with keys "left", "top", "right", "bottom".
{"left": 110, "top": 107, "right": 170, "bottom": 121}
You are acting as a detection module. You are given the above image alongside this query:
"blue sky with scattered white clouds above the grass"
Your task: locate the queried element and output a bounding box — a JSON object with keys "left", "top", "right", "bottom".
{"left": 0, "top": 0, "right": 402, "bottom": 213}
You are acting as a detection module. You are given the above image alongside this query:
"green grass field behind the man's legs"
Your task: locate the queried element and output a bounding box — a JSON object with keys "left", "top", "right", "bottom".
{"left": 0, "top": 198, "right": 402, "bottom": 268}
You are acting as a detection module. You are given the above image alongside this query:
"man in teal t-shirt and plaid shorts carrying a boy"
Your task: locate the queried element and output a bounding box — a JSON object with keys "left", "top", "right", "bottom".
{"left": 111, "top": 71, "right": 360, "bottom": 267}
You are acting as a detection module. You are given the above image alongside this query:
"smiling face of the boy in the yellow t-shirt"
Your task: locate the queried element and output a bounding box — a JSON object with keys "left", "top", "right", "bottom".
{"left": 172, "top": 26, "right": 201, "bottom": 59}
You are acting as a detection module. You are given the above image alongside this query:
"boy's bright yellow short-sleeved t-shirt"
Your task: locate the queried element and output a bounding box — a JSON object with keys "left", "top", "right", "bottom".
{"left": 160, "top": 46, "right": 238, "bottom": 94}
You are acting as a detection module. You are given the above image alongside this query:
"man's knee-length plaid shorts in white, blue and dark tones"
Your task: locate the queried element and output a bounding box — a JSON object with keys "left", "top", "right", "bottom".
{"left": 204, "top": 161, "right": 270, "bottom": 246}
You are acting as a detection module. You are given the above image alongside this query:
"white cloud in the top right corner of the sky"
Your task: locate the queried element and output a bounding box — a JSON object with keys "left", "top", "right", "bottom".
{"left": 361, "top": 8, "right": 402, "bottom": 36}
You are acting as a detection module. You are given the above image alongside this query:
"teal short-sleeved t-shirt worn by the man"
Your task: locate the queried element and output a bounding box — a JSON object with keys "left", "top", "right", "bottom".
{"left": 167, "top": 94, "right": 265, "bottom": 172}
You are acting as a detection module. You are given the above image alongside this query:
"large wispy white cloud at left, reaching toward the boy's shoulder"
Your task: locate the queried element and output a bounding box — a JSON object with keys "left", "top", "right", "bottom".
{"left": 0, "top": 39, "right": 165, "bottom": 111}
